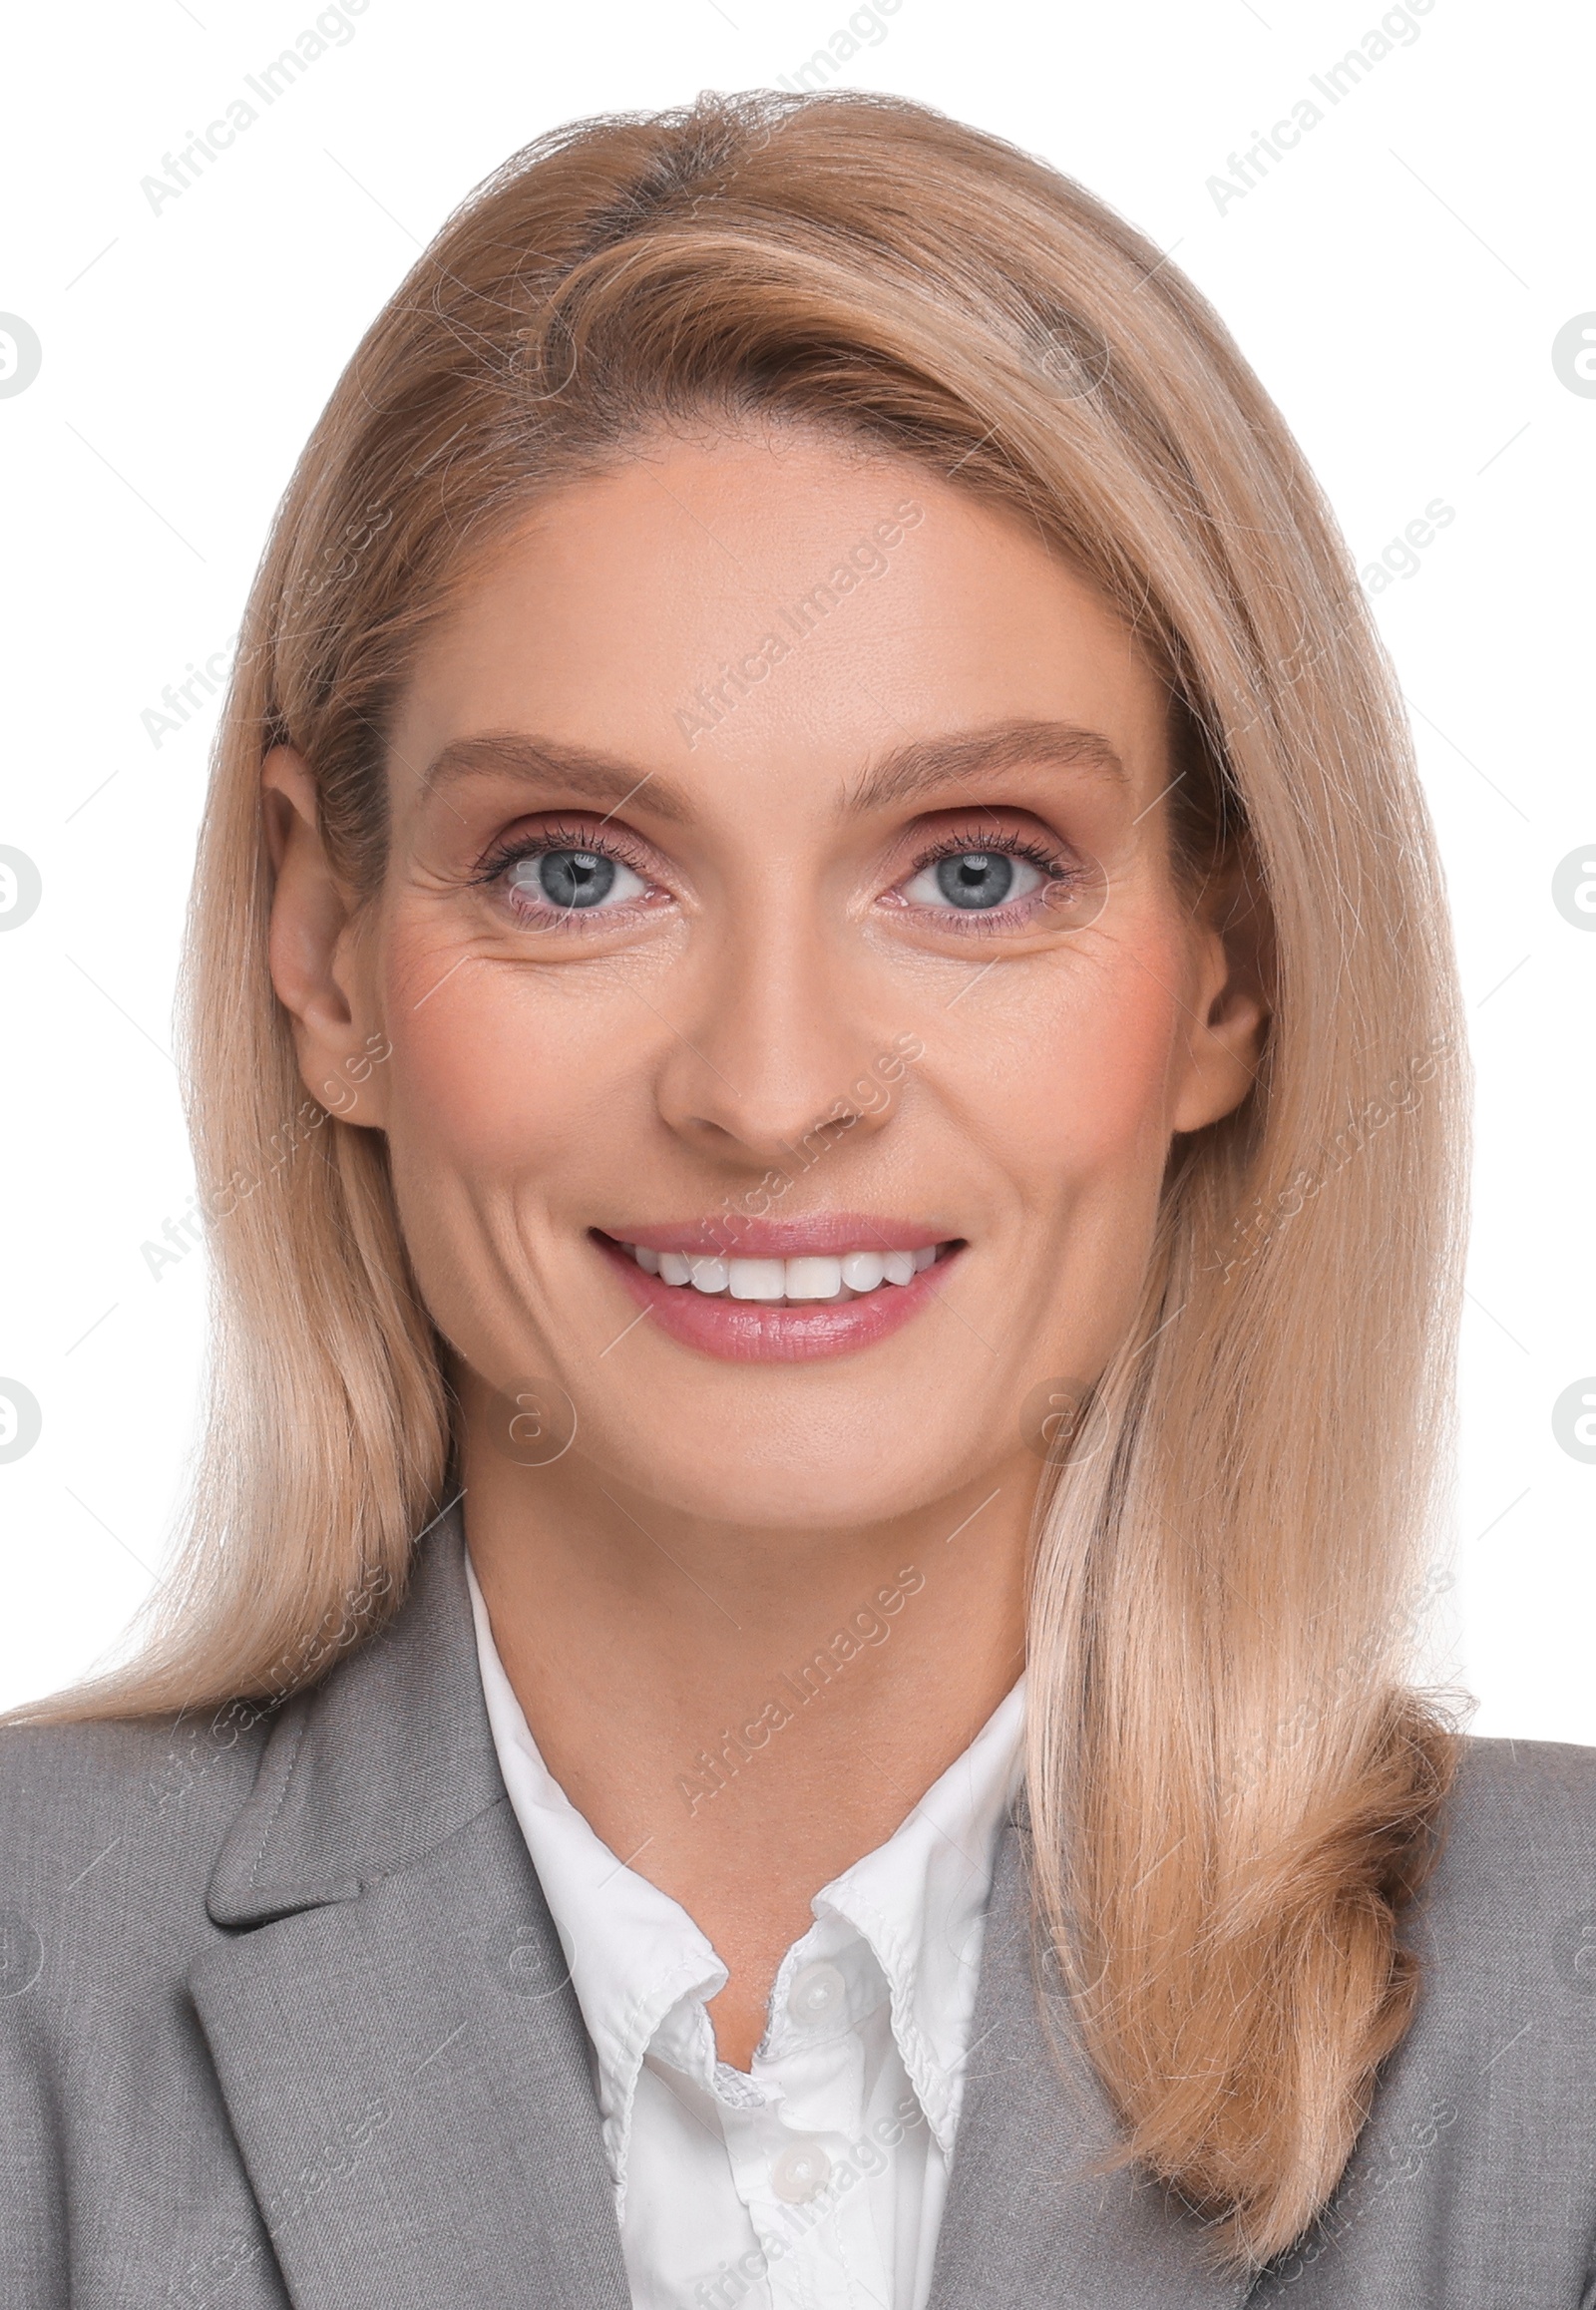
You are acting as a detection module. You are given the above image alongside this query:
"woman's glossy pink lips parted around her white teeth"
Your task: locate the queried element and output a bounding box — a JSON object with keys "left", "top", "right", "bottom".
{"left": 589, "top": 1220, "right": 964, "bottom": 1362}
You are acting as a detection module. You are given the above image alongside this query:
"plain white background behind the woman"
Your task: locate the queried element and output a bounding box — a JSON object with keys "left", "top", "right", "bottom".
{"left": 0, "top": 0, "right": 1596, "bottom": 1741}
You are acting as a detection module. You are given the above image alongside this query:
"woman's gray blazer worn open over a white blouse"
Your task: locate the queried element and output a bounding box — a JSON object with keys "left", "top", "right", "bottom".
{"left": 0, "top": 1515, "right": 1596, "bottom": 2310}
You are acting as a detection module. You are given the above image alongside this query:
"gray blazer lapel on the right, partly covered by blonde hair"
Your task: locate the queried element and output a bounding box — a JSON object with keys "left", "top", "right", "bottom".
{"left": 929, "top": 1825, "right": 1252, "bottom": 2310}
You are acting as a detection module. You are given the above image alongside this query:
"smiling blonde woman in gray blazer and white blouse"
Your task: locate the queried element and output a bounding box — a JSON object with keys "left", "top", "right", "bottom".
{"left": 5, "top": 97, "right": 1596, "bottom": 2310}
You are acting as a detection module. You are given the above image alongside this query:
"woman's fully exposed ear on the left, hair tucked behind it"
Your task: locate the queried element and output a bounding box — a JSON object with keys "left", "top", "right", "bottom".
{"left": 261, "top": 746, "right": 390, "bottom": 1130}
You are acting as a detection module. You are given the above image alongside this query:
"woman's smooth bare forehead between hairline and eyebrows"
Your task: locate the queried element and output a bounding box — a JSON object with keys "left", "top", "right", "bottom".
{"left": 395, "top": 432, "right": 1169, "bottom": 822}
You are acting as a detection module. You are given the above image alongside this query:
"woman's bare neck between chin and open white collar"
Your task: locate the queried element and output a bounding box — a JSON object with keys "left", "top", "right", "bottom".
{"left": 462, "top": 1411, "right": 1037, "bottom": 2063}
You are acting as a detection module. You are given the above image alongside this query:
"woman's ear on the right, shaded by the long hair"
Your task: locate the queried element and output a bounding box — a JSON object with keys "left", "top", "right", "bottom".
{"left": 1171, "top": 850, "right": 1275, "bottom": 1132}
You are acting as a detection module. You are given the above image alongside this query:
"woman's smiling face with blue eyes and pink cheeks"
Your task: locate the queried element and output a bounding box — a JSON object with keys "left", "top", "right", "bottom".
{"left": 268, "top": 432, "right": 1259, "bottom": 1527}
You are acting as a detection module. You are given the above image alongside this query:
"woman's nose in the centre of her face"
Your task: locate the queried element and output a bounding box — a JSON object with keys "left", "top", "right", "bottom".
{"left": 656, "top": 920, "right": 903, "bottom": 1169}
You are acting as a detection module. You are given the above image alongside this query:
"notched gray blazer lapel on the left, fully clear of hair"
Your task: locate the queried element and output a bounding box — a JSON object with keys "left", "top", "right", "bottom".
{"left": 190, "top": 1515, "right": 628, "bottom": 2310}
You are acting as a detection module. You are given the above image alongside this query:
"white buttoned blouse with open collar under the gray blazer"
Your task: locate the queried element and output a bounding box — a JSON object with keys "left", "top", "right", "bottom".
{"left": 469, "top": 1573, "right": 1023, "bottom": 2310}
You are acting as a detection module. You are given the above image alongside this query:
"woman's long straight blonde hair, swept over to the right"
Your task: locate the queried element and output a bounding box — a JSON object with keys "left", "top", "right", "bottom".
{"left": 32, "top": 95, "right": 1464, "bottom": 2261}
